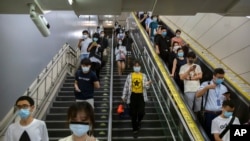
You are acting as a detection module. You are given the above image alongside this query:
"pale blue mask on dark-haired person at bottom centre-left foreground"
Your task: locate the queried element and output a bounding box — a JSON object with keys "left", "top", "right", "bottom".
{"left": 69, "top": 123, "right": 89, "bottom": 137}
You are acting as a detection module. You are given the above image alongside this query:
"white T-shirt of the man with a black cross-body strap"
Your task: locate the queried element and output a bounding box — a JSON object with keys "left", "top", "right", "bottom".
{"left": 211, "top": 115, "right": 240, "bottom": 141}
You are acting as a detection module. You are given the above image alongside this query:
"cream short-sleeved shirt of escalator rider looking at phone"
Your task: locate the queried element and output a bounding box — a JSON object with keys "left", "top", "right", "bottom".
{"left": 179, "top": 64, "right": 202, "bottom": 93}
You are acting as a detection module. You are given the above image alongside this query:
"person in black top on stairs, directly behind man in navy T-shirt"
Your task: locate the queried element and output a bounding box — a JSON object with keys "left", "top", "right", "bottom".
{"left": 87, "top": 33, "right": 103, "bottom": 80}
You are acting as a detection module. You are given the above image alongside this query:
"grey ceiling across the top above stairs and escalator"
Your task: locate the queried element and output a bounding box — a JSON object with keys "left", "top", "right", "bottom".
{"left": 0, "top": 0, "right": 250, "bottom": 27}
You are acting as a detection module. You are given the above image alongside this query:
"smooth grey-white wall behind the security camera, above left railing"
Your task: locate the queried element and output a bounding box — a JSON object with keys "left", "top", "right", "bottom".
{"left": 0, "top": 11, "right": 93, "bottom": 119}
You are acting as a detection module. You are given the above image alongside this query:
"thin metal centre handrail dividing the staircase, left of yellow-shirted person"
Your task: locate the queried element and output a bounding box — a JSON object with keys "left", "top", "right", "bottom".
{"left": 108, "top": 32, "right": 114, "bottom": 141}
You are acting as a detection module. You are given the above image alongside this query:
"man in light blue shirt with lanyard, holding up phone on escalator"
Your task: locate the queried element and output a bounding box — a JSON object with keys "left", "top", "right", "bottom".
{"left": 196, "top": 68, "right": 228, "bottom": 141}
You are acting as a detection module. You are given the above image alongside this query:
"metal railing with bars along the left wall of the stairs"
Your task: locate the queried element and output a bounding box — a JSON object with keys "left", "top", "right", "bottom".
{"left": 0, "top": 43, "right": 77, "bottom": 137}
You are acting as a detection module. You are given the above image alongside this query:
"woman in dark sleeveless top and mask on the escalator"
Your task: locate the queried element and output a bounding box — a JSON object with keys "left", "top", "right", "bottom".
{"left": 171, "top": 48, "right": 187, "bottom": 93}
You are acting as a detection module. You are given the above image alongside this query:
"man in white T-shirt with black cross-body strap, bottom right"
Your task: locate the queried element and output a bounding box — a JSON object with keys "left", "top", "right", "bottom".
{"left": 211, "top": 100, "right": 240, "bottom": 141}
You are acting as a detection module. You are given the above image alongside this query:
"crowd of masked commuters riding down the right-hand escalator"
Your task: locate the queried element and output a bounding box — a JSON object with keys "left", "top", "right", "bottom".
{"left": 136, "top": 12, "right": 245, "bottom": 141}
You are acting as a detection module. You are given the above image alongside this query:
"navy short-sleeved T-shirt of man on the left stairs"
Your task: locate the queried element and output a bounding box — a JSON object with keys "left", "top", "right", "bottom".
{"left": 75, "top": 70, "right": 98, "bottom": 100}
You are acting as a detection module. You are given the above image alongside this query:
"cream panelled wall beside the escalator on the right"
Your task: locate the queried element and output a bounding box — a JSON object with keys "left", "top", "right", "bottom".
{"left": 164, "top": 13, "right": 250, "bottom": 83}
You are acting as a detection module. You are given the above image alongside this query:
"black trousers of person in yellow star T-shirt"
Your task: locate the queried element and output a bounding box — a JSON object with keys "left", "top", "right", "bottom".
{"left": 129, "top": 93, "right": 145, "bottom": 131}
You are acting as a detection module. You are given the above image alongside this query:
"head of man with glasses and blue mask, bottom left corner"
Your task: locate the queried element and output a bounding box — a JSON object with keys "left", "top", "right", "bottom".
{"left": 15, "top": 96, "right": 35, "bottom": 120}
